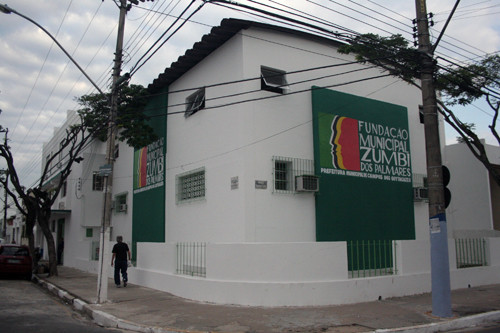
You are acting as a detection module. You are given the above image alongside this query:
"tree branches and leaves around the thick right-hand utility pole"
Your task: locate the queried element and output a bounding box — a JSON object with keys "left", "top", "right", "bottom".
{"left": 339, "top": 34, "right": 500, "bottom": 186}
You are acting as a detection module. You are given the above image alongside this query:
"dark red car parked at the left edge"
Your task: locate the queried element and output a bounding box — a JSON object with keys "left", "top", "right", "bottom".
{"left": 0, "top": 244, "right": 33, "bottom": 280}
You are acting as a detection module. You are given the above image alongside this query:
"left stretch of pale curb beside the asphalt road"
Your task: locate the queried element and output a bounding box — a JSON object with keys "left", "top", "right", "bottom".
{"left": 33, "top": 274, "right": 210, "bottom": 333}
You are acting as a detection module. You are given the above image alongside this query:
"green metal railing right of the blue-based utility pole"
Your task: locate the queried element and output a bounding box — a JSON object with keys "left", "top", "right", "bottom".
{"left": 455, "top": 238, "right": 488, "bottom": 268}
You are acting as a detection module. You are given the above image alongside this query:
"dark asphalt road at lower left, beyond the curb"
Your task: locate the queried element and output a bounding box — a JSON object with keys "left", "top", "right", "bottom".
{"left": 0, "top": 278, "right": 131, "bottom": 333}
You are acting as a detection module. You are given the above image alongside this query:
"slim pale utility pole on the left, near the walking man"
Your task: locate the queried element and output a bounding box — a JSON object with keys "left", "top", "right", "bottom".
{"left": 97, "top": 0, "right": 127, "bottom": 303}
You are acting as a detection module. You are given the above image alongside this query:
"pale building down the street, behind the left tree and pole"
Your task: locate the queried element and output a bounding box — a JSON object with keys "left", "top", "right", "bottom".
{"left": 39, "top": 111, "right": 133, "bottom": 272}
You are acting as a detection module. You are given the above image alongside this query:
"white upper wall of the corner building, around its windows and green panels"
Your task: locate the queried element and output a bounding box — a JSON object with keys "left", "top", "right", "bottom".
{"left": 166, "top": 25, "right": 428, "bottom": 242}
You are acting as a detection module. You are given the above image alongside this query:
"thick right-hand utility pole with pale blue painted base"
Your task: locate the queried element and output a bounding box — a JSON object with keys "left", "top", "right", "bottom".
{"left": 415, "top": 0, "right": 452, "bottom": 317}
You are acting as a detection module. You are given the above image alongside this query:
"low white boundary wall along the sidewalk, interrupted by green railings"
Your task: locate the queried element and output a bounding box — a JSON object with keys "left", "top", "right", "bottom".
{"left": 129, "top": 238, "right": 500, "bottom": 306}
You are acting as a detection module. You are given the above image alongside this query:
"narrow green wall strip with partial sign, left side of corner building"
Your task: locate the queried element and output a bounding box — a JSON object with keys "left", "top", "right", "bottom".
{"left": 132, "top": 89, "right": 167, "bottom": 260}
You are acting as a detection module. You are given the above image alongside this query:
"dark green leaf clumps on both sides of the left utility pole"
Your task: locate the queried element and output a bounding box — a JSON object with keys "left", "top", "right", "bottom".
{"left": 77, "top": 85, "right": 158, "bottom": 148}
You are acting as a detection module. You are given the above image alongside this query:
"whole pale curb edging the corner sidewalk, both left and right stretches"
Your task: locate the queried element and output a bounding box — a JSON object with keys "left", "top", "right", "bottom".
{"left": 33, "top": 274, "right": 500, "bottom": 333}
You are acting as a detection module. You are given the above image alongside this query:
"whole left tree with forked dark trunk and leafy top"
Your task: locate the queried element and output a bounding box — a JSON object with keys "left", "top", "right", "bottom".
{"left": 0, "top": 85, "right": 157, "bottom": 276}
